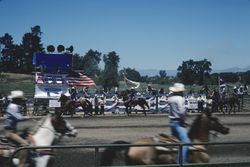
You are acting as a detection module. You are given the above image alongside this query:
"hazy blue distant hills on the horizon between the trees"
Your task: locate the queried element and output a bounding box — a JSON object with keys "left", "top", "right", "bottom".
{"left": 138, "top": 66, "right": 250, "bottom": 77}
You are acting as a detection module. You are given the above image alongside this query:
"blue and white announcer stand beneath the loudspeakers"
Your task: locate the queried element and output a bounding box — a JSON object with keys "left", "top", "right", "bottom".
{"left": 33, "top": 53, "right": 72, "bottom": 115}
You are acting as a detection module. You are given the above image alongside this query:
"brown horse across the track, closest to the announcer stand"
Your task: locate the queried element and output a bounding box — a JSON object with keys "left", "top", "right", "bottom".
{"left": 58, "top": 94, "right": 93, "bottom": 116}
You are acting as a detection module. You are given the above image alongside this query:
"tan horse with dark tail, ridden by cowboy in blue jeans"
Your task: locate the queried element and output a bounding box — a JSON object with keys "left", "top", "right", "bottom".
{"left": 100, "top": 109, "right": 229, "bottom": 166}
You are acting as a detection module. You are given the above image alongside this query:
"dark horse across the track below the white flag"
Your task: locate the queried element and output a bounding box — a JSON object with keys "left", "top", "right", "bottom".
{"left": 123, "top": 95, "right": 149, "bottom": 116}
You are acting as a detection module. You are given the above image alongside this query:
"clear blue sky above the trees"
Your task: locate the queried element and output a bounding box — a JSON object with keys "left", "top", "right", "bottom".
{"left": 0, "top": 0, "right": 250, "bottom": 70}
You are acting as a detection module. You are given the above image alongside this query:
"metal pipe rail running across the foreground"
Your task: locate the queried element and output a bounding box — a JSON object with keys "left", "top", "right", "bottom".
{"left": 10, "top": 141, "right": 250, "bottom": 167}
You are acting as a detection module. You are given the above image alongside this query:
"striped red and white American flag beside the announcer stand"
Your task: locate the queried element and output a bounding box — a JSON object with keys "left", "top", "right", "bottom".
{"left": 66, "top": 72, "right": 96, "bottom": 87}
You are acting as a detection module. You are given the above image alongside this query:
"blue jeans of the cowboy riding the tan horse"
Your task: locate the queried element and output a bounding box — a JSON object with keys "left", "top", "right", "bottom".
{"left": 170, "top": 120, "right": 190, "bottom": 164}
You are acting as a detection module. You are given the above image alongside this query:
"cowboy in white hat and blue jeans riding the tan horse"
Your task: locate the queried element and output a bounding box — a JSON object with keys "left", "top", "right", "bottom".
{"left": 168, "top": 83, "right": 190, "bottom": 163}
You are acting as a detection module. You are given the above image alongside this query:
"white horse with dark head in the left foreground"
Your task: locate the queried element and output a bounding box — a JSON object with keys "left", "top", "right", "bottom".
{"left": 0, "top": 111, "right": 77, "bottom": 167}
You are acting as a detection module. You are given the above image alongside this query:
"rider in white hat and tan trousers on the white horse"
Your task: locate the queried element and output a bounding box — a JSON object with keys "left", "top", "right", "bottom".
{"left": 4, "top": 90, "right": 28, "bottom": 146}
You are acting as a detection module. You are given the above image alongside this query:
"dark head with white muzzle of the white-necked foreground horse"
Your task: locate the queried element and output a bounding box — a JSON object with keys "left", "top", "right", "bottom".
{"left": 51, "top": 111, "right": 77, "bottom": 137}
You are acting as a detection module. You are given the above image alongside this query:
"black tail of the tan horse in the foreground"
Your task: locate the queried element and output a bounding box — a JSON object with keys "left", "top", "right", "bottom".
{"left": 100, "top": 140, "right": 130, "bottom": 166}
